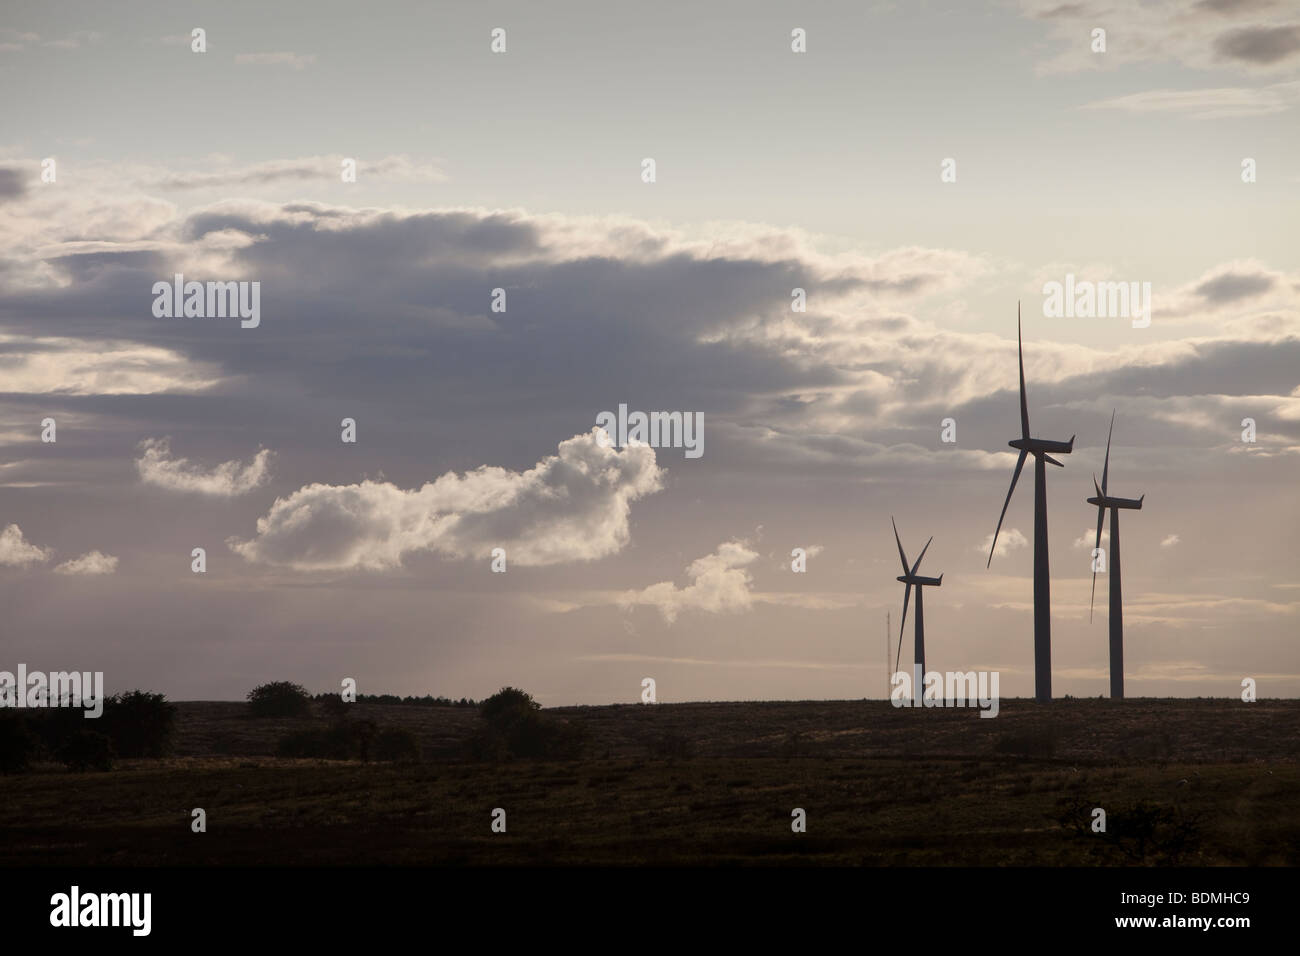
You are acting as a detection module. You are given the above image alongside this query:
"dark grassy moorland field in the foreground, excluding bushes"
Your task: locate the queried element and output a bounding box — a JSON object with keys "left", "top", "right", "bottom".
{"left": 0, "top": 700, "right": 1300, "bottom": 866}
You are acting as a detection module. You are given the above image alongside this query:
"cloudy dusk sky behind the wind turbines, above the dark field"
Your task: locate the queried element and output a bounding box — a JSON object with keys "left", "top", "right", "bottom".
{"left": 0, "top": 0, "right": 1300, "bottom": 705}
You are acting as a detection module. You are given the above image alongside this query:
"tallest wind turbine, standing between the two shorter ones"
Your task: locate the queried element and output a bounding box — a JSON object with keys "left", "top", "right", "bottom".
{"left": 985, "top": 303, "right": 1075, "bottom": 701}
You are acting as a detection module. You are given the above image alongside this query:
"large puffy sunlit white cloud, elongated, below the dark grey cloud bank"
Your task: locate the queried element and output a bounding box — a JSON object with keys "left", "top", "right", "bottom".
{"left": 228, "top": 428, "right": 662, "bottom": 571}
